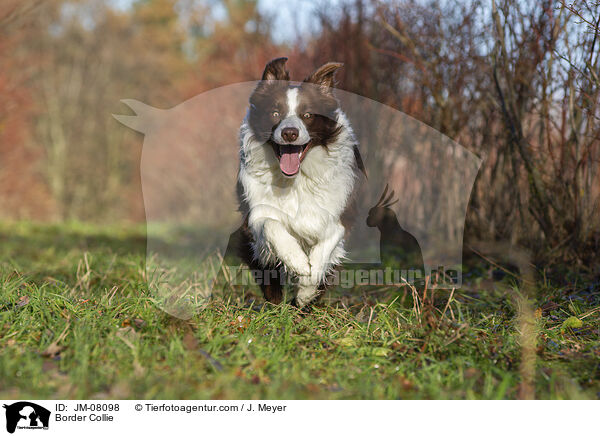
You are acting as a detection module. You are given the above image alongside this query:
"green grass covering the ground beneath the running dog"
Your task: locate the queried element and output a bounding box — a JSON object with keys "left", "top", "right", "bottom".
{"left": 0, "top": 223, "right": 600, "bottom": 399}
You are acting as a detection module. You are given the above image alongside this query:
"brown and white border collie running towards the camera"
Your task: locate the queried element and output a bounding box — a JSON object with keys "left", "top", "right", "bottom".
{"left": 238, "top": 58, "right": 364, "bottom": 307}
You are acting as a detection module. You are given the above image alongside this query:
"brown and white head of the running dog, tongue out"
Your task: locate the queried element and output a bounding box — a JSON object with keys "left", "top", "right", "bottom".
{"left": 249, "top": 58, "right": 342, "bottom": 177}
